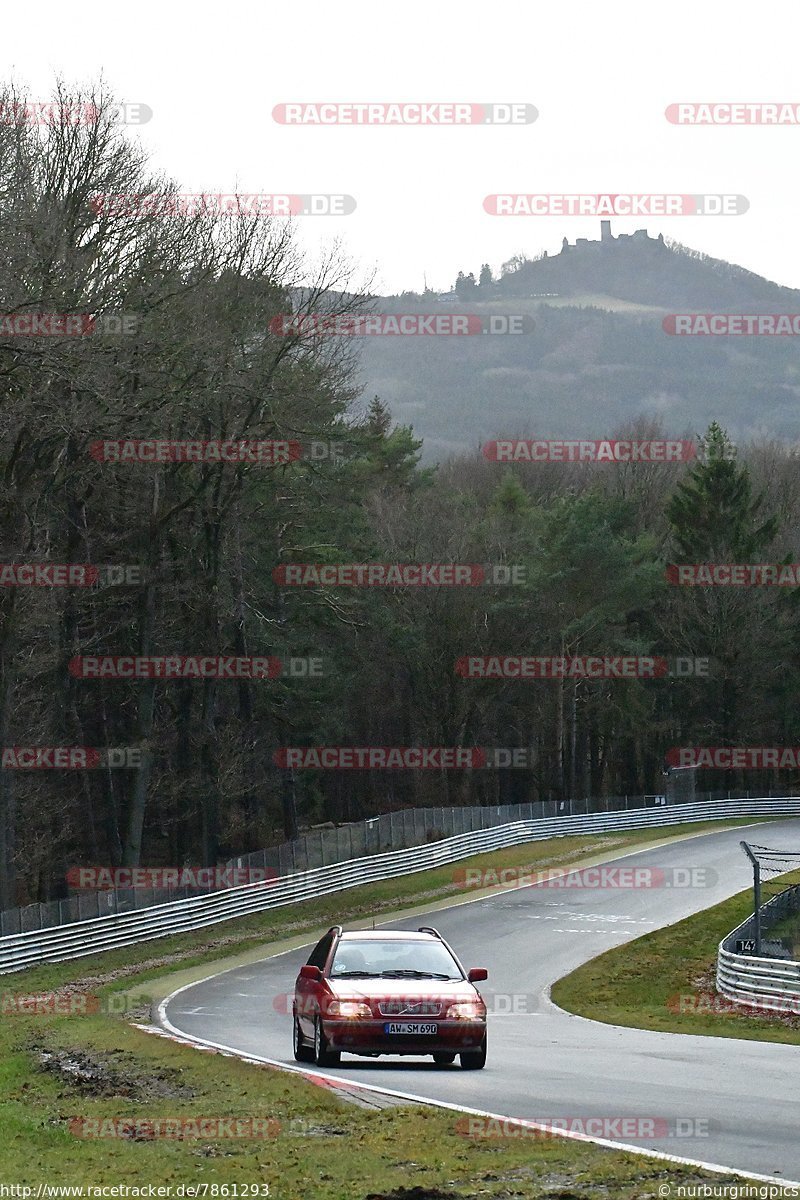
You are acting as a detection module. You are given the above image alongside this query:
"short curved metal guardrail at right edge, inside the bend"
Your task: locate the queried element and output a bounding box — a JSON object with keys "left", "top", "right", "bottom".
{"left": 717, "top": 887, "right": 800, "bottom": 1012}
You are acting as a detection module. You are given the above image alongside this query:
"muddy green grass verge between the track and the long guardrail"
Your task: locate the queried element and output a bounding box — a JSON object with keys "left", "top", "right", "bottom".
{"left": 0, "top": 822, "right": 786, "bottom": 1200}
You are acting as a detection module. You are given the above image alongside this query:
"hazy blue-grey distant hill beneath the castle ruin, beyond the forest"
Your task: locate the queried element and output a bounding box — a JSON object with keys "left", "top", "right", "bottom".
{"left": 359, "top": 226, "right": 800, "bottom": 461}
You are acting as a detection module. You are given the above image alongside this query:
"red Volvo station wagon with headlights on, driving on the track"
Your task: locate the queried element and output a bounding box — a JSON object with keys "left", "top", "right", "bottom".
{"left": 291, "top": 925, "right": 488, "bottom": 1070}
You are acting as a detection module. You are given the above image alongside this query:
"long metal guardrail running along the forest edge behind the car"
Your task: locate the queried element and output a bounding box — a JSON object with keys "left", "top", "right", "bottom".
{"left": 0, "top": 797, "right": 800, "bottom": 974}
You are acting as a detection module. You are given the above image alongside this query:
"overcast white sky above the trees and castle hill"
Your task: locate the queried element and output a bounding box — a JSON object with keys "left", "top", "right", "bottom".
{"left": 6, "top": 0, "right": 800, "bottom": 292}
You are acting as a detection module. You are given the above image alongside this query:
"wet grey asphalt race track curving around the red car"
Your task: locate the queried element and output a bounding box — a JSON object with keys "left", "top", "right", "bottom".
{"left": 159, "top": 820, "right": 800, "bottom": 1181}
